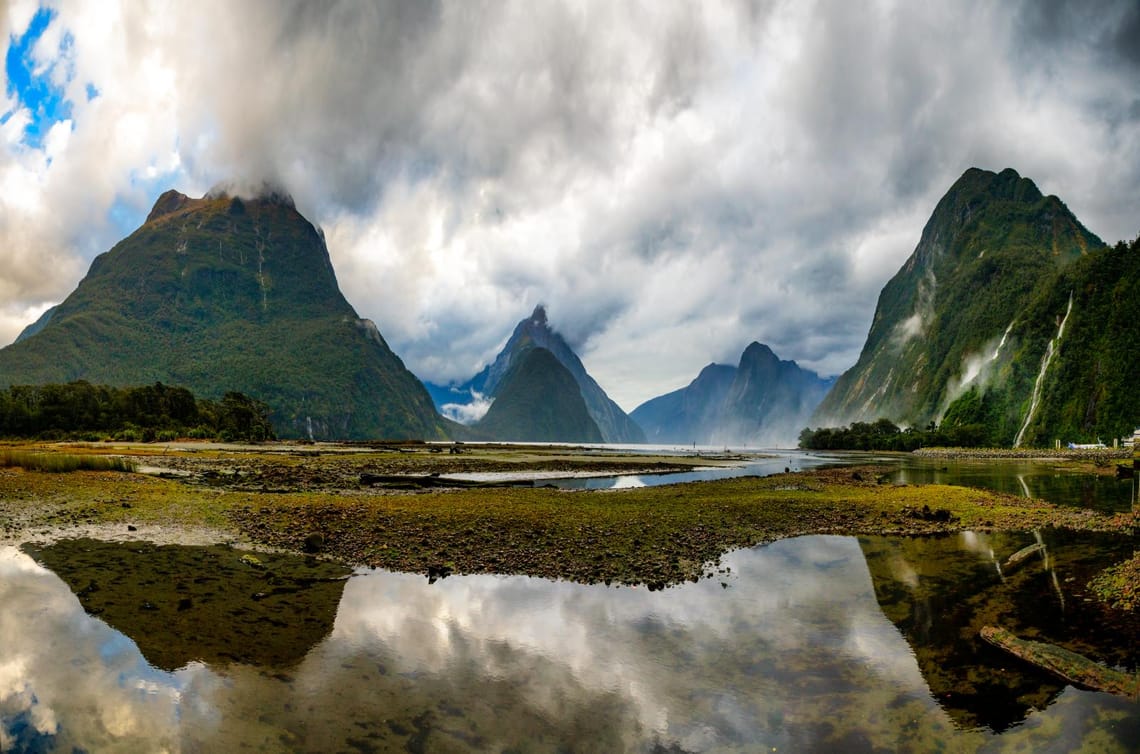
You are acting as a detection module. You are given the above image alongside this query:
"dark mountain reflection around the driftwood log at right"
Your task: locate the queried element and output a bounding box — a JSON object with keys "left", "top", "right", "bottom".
{"left": 860, "top": 532, "right": 1140, "bottom": 732}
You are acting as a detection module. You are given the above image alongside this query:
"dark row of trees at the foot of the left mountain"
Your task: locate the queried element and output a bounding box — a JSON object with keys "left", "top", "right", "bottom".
{"left": 0, "top": 380, "right": 276, "bottom": 441}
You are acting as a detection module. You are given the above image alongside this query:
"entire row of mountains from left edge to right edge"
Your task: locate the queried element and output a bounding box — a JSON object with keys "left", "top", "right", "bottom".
{"left": 0, "top": 169, "right": 1140, "bottom": 446}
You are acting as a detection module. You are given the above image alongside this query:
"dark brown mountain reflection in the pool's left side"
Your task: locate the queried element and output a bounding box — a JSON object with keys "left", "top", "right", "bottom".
{"left": 25, "top": 540, "right": 349, "bottom": 671}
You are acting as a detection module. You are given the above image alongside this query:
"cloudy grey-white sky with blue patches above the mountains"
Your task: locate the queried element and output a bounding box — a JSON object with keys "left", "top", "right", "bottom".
{"left": 0, "top": 0, "right": 1140, "bottom": 411}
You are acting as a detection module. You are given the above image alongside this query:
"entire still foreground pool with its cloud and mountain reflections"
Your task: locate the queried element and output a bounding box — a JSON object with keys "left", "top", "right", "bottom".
{"left": 0, "top": 532, "right": 1140, "bottom": 752}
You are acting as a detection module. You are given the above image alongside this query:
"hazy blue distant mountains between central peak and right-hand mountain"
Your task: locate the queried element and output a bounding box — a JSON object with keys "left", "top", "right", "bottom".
{"left": 632, "top": 342, "right": 832, "bottom": 447}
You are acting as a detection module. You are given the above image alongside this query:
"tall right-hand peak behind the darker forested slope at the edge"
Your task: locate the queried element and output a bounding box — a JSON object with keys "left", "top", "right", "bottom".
{"left": 812, "top": 168, "right": 1104, "bottom": 439}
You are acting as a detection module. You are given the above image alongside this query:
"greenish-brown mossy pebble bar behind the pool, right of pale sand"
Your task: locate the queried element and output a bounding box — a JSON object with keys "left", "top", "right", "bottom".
{"left": 229, "top": 470, "right": 1131, "bottom": 587}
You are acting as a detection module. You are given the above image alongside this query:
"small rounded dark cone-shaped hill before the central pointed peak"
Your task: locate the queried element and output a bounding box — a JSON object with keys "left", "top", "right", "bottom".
{"left": 473, "top": 346, "right": 603, "bottom": 443}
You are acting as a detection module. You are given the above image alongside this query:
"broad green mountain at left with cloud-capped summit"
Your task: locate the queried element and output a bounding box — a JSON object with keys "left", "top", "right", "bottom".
{"left": 0, "top": 183, "right": 446, "bottom": 439}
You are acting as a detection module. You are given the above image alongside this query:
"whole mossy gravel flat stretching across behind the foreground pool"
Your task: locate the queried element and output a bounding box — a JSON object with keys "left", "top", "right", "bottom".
{"left": 0, "top": 447, "right": 1135, "bottom": 587}
